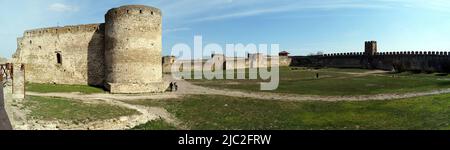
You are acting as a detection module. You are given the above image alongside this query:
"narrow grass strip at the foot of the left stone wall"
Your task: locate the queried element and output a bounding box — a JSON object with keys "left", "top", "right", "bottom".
{"left": 26, "top": 83, "right": 105, "bottom": 94}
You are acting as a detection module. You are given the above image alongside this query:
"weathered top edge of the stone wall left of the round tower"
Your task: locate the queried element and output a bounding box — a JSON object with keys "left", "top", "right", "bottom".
{"left": 23, "top": 24, "right": 104, "bottom": 37}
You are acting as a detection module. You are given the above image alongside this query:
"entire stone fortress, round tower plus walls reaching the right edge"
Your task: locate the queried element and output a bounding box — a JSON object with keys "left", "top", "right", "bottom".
{"left": 13, "top": 5, "right": 450, "bottom": 93}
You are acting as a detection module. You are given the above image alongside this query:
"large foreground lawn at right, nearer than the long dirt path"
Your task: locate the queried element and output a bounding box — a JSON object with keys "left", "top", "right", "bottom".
{"left": 128, "top": 94, "right": 450, "bottom": 130}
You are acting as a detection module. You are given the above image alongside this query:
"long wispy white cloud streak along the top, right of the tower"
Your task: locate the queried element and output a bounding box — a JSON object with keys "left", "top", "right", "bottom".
{"left": 162, "top": 0, "right": 450, "bottom": 23}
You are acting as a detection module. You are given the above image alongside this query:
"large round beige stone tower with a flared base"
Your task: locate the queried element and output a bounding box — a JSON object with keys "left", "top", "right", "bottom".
{"left": 105, "top": 5, "right": 165, "bottom": 93}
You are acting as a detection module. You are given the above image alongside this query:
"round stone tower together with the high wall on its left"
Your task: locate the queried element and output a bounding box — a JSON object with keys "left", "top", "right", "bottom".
{"left": 13, "top": 5, "right": 167, "bottom": 93}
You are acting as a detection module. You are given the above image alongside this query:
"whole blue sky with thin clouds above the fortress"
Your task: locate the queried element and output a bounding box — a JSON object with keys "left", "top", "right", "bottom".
{"left": 0, "top": 0, "right": 450, "bottom": 58}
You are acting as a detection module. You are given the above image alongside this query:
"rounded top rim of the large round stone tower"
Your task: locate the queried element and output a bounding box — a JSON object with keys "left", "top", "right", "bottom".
{"left": 105, "top": 5, "right": 161, "bottom": 18}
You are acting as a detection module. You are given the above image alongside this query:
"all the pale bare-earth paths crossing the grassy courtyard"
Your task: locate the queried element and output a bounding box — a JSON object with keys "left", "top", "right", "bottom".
{"left": 7, "top": 71, "right": 450, "bottom": 130}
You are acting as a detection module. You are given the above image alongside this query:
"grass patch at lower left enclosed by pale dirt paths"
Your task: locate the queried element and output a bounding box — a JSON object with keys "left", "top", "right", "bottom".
{"left": 25, "top": 96, "right": 139, "bottom": 122}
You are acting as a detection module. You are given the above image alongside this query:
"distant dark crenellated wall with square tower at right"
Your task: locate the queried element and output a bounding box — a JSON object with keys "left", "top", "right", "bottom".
{"left": 290, "top": 41, "right": 450, "bottom": 73}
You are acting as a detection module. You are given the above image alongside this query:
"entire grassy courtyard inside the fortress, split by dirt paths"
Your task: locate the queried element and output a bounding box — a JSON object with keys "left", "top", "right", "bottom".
{"left": 20, "top": 67, "right": 450, "bottom": 130}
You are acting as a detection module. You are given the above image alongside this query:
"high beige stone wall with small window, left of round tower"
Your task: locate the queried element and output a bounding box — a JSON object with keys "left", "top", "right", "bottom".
{"left": 13, "top": 24, "right": 104, "bottom": 85}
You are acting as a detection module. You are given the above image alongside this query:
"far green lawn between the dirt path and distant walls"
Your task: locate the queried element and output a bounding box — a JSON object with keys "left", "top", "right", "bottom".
{"left": 189, "top": 67, "right": 450, "bottom": 96}
